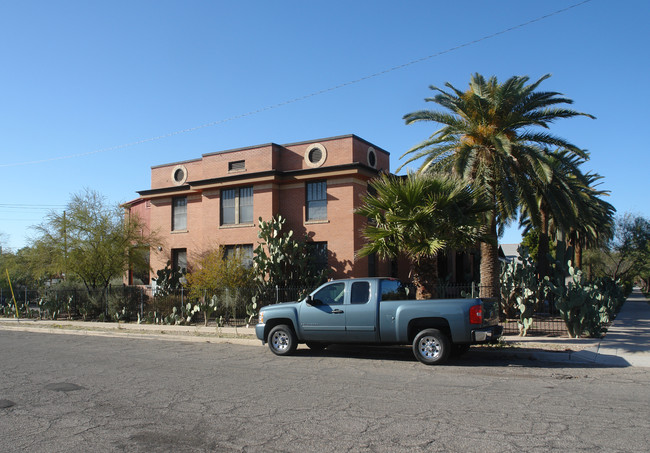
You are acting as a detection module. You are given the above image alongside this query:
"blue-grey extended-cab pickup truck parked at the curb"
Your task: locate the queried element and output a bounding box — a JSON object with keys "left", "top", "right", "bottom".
{"left": 255, "top": 278, "right": 502, "bottom": 365}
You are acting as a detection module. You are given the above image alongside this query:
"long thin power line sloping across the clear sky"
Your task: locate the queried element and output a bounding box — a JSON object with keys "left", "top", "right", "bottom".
{"left": 0, "top": 0, "right": 593, "bottom": 168}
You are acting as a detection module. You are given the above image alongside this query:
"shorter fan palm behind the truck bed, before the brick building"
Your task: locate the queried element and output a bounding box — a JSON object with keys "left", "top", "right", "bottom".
{"left": 356, "top": 174, "right": 489, "bottom": 299}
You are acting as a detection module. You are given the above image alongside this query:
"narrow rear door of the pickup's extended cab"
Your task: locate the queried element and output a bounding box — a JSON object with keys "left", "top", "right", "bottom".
{"left": 345, "top": 281, "right": 377, "bottom": 343}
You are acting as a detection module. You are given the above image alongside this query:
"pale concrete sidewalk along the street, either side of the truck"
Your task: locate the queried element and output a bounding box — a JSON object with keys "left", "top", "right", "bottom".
{"left": 0, "top": 289, "right": 650, "bottom": 367}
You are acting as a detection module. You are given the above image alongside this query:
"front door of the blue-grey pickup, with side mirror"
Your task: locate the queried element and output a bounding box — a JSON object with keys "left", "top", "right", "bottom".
{"left": 300, "top": 282, "right": 346, "bottom": 343}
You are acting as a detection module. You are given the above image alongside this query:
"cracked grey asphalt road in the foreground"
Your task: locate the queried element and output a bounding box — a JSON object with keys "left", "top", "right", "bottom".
{"left": 0, "top": 331, "right": 650, "bottom": 452}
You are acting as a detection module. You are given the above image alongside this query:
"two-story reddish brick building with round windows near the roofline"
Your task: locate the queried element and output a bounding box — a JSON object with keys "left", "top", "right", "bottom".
{"left": 124, "top": 135, "right": 406, "bottom": 283}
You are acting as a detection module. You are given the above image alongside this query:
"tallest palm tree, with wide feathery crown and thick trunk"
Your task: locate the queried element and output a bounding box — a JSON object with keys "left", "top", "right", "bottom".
{"left": 398, "top": 74, "right": 593, "bottom": 297}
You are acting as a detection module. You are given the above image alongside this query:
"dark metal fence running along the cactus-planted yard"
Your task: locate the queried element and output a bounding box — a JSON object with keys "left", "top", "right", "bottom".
{"left": 0, "top": 284, "right": 566, "bottom": 336}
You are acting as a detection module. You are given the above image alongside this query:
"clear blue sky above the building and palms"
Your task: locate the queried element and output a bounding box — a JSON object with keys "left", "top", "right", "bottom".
{"left": 0, "top": 0, "right": 650, "bottom": 250}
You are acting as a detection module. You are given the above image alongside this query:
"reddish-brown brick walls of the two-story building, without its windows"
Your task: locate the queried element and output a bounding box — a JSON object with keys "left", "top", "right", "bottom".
{"left": 134, "top": 136, "right": 390, "bottom": 278}
